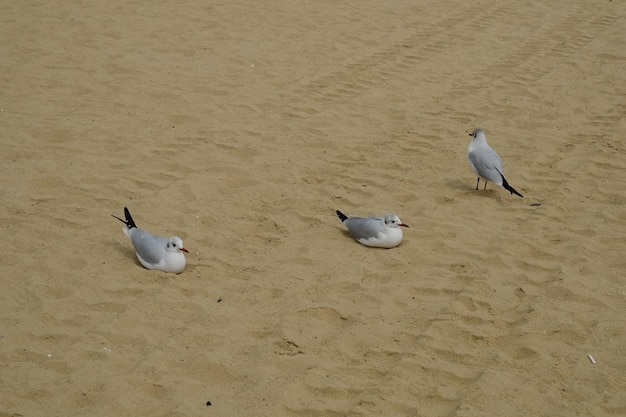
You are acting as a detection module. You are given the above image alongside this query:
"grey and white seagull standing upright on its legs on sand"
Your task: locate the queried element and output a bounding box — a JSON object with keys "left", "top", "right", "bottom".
{"left": 467, "top": 129, "right": 524, "bottom": 197}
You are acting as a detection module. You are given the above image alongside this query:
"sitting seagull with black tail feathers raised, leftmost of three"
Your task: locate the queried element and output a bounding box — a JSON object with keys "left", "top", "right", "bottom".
{"left": 112, "top": 207, "right": 189, "bottom": 274}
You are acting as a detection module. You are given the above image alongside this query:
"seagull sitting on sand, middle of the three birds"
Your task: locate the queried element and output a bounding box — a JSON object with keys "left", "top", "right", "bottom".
{"left": 337, "top": 210, "right": 409, "bottom": 248}
